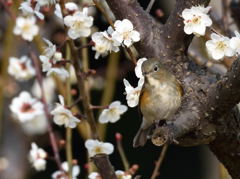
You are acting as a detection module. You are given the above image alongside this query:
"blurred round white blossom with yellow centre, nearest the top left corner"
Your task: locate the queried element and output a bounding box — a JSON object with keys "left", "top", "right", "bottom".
{"left": 13, "top": 16, "right": 39, "bottom": 41}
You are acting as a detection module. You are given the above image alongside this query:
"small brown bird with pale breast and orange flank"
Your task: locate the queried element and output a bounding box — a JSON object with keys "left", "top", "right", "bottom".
{"left": 133, "top": 58, "right": 183, "bottom": 147}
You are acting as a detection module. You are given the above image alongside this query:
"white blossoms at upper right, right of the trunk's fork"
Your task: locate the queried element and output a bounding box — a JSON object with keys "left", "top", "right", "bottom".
{"left": 182, "top": 6, "right": 240, "bottom": 60}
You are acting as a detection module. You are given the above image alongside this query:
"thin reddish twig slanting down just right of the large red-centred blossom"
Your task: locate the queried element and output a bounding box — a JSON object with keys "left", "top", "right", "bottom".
{"left": 30, "top": 52, "right": 62, "bottom": 170}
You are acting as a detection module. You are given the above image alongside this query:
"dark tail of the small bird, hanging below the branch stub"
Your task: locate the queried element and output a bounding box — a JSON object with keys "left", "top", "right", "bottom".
{"left": 133, "top": 127, "right": 151, "bottom": 147}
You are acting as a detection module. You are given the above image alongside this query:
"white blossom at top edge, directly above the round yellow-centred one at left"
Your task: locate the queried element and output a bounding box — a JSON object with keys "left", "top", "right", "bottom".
{"left": 19, "top": 0, "right": 44, "bottom": 20}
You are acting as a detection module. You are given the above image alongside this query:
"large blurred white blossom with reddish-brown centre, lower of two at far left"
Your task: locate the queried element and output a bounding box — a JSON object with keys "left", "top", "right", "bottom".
{"left": 10, "top": 91, "right": 44, "bottom": 122}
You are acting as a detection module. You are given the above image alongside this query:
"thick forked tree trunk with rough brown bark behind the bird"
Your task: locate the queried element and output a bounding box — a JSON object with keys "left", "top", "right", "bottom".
{"left": 106, "top": 0, "right": 240, "bottom": 179}
